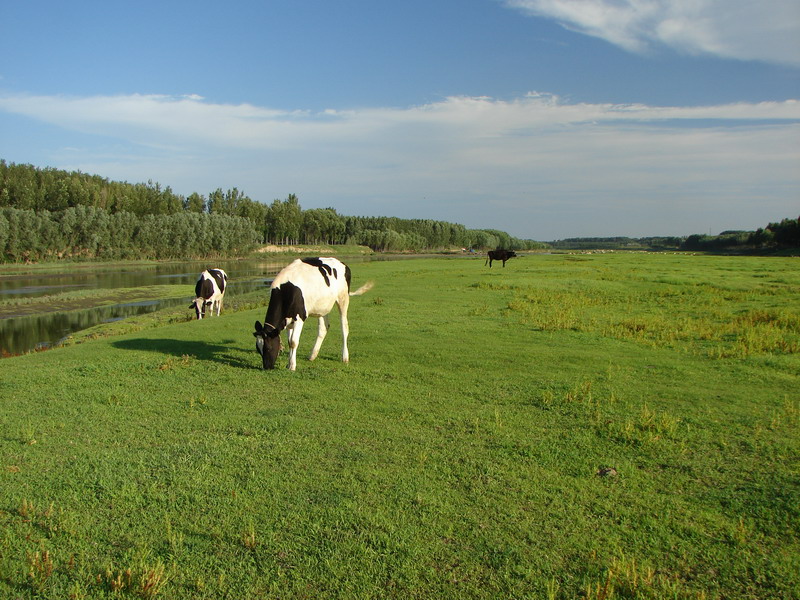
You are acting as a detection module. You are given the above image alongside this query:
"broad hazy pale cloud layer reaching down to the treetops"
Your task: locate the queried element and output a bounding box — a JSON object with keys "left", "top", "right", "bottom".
{"left": 0, "top": 93, "right": 800, "bottom": 239}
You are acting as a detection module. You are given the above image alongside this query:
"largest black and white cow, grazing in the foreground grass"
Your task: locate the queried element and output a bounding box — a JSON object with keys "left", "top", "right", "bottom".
{"left": 253, "top": 258, "right": 372, "bottom": 371}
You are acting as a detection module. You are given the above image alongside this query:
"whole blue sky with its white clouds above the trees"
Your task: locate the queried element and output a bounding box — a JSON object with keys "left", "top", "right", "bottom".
{"left": 0, "top": 0, "right": 800, "bottom": 240}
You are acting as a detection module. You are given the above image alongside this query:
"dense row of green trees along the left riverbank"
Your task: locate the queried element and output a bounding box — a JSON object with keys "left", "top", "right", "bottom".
{"left": 0, "top": 160, "right": 542, "bottom": 260}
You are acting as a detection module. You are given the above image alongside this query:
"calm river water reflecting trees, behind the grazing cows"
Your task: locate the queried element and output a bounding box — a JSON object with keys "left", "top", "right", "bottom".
{"left": 0, "top": 257, "right": 382, "bottom": 357}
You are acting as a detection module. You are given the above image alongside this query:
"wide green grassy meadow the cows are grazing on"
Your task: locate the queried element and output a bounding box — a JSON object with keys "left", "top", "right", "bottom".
{"left": 0, "top": 254, "right": 800, "bottom": 600}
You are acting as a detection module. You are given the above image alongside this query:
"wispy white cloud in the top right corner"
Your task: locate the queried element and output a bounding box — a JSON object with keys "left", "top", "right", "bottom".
{"left": 506, "top": 0, "right": 800, "bottom": 66}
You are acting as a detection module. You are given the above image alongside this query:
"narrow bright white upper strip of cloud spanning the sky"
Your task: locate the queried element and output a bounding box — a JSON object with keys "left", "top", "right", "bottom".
{"left": 0, "top": 92, "right": 800, "bottom": 149}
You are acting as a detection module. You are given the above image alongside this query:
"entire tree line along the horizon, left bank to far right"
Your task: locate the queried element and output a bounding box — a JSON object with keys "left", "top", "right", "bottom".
{"left": 9, "top": 159, "right": 800, "bottom": 261}
